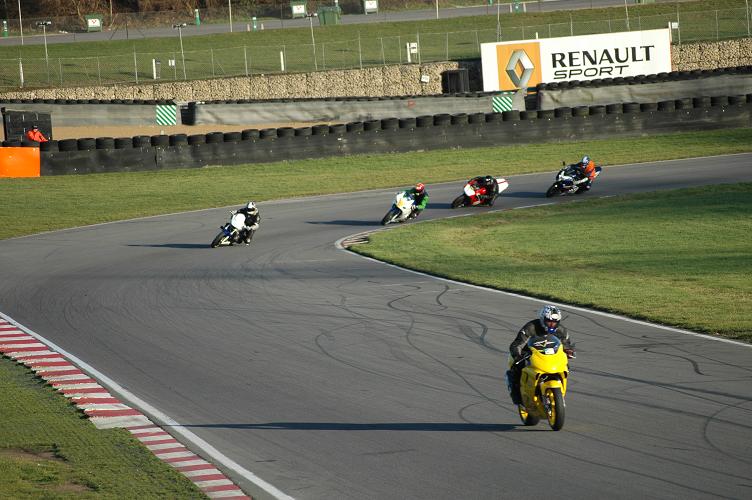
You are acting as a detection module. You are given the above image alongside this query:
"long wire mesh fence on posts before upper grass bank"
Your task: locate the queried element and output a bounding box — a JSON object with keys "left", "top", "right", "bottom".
{"left": 0, "top": 8, "right": 752, "bottom": 91}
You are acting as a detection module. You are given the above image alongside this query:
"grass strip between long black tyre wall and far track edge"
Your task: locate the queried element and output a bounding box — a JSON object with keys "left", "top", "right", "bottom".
{"left": 0, "top": 128, "right": 752, "bottom": 239}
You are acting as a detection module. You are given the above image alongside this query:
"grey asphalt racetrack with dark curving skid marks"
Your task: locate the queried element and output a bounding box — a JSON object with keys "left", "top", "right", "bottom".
{"left": 0, "top": 154, "right": 752, "bottom": 499}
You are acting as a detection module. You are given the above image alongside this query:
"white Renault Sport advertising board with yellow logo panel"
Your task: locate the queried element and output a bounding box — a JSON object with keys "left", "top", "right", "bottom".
{"left": 480, "top": 28, "right": 671, "bottom": 92}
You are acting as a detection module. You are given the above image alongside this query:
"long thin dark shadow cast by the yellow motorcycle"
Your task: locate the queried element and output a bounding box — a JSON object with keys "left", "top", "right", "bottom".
{"left": 181, "top": 422, "right": 524, "bottom": 432}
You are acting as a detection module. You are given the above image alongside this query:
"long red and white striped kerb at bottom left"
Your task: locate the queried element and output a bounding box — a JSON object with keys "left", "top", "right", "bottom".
{"left": 0, "top": 318, "right": 251, "bottom": 499}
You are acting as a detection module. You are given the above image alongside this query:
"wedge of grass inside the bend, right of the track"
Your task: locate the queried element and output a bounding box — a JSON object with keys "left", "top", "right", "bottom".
{"left": 353, "top": 184, "right": 752, "bottom": 342}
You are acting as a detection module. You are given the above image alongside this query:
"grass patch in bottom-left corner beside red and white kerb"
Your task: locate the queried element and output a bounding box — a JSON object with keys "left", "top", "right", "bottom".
{"left": 0, "top": 357, "right": 206, "bottom": 499}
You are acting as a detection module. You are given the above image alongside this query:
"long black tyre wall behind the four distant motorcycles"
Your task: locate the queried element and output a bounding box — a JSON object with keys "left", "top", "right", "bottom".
{"left": 40, "top": 94, "right": 752, "bottom": 175}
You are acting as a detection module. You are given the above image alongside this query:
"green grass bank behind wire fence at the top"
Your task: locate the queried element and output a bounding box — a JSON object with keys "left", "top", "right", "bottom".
{"left": 0, "top": 0, "right": 748, "bottom": 89}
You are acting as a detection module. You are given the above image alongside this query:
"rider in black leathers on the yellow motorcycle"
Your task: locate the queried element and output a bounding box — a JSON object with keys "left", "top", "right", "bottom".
{"left": 507, "top": 305, "right": 574, "bottom": 405}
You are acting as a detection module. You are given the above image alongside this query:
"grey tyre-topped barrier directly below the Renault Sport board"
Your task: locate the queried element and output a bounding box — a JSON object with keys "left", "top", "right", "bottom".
{"left": 538, "top": 67, "right": 752, "bottom": 109}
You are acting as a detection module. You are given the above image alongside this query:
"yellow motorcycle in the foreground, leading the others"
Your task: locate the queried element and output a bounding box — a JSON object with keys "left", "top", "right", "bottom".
{"left": 507, "top": 335, "right": 574, "bottom": 431}
